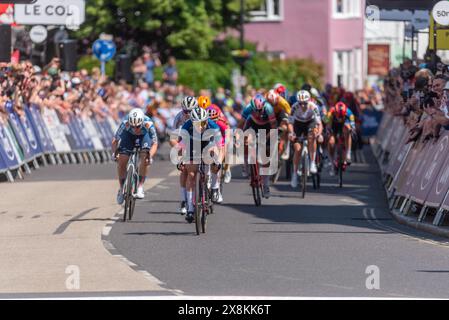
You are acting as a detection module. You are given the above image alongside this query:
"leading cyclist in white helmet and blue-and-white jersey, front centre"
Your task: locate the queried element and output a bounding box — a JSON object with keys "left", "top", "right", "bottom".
{"left": 178, "top": 107, "right": 222, "bottom": 223}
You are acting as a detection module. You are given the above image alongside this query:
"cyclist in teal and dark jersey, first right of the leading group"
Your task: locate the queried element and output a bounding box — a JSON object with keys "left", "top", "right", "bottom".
{"left": 238, "top": 94, "right": 276, "bottom": 199}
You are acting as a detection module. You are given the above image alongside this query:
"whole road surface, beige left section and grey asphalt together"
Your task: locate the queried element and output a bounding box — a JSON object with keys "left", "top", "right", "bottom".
{"left": 0, "top": 147, "right": 449, "bottom": 298}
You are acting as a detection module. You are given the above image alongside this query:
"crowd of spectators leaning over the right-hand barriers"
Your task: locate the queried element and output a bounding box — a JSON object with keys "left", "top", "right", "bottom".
{"left": 384, "top": 55, "right": 449, "bottom": 143}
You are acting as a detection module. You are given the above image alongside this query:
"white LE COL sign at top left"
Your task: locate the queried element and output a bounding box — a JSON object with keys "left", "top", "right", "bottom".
{"left": 14, "top": 0, "right": 86, "bottom": 28}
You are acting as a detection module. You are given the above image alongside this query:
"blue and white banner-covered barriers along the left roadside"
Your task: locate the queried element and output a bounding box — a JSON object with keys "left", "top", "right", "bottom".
{"left": 0, "top": 102, "right": 118, "bottom": 182}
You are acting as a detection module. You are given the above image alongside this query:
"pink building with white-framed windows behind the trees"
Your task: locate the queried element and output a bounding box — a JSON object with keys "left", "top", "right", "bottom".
{"left": 245, "top": 0, "right": 365, "bottom": 90}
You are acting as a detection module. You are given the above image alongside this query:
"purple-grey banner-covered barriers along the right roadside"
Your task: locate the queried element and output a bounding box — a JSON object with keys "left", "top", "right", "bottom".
{"left": 373, "top": 112, "right": 449, "bottom": 226}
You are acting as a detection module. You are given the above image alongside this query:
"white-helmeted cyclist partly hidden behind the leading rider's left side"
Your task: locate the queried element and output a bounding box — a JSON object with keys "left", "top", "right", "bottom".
{"left": 170, "top": 97, "right": 198, "bottom": 215}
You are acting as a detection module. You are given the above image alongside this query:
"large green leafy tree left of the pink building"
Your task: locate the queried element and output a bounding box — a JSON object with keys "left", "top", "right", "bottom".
{"left": 77, "top": 0, "right": 262, "bottom": 59}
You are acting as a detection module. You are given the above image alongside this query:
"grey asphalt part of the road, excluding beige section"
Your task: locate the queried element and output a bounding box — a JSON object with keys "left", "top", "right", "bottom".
{"left": 109, "top": 148, "right": 449, "bottom": 298}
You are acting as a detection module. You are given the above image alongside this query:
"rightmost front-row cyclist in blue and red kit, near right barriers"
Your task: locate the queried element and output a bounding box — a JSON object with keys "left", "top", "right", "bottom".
{"left": 326, "top": 101, "right": 355, "bottom": 175}
